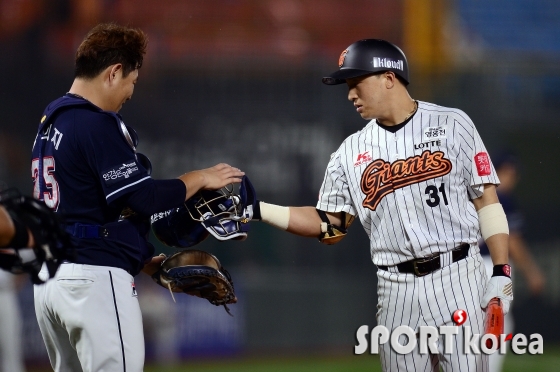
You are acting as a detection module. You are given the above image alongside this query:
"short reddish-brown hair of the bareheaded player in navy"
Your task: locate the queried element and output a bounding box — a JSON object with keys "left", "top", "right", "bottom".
{"left": 74, "top": 23, "right": 148, "bottom": 79}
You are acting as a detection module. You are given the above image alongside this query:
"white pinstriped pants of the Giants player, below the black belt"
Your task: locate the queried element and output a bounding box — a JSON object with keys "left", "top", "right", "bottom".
{"left": 377, "top": 248, "right": 488, "bottom": 372}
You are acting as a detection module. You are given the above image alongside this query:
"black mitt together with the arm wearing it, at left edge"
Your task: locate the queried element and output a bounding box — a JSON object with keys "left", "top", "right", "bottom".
{"left": 0, "top": 189, "right": 72, "bottom": 284}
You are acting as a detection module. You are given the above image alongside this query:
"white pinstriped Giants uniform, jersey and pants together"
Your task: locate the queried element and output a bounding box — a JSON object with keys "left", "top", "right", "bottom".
{"left": 317, "top": 102, "right": 499, "bottom": 372}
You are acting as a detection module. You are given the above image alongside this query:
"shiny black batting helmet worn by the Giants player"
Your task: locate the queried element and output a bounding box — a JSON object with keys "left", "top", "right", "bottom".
{"left": 323, "top": 39, "right": 408, "bottom": 85}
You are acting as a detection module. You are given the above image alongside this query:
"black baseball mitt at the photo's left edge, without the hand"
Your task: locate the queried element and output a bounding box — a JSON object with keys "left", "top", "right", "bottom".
{"left": 0, "top": 188, "right": 73, "bottom": 284}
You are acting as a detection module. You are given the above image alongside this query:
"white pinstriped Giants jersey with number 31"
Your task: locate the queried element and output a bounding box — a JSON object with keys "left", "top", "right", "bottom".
{"left": 317, "top": 102, "right": 499, "bottom": 266}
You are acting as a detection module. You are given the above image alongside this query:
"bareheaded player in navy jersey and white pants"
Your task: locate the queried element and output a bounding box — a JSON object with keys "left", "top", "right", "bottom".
{"left": 31, "top": 24, "right": 244, "bottom": 372}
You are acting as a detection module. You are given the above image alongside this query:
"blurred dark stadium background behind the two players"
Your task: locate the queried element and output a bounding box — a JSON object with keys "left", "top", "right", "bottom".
{"left": 0, "top": 0, "right": 560, "bottom": 368}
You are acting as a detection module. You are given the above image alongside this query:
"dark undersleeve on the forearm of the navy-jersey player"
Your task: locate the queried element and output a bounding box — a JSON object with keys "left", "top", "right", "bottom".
{"left": 121, "top": 179, "right": 187, "bottom": 217}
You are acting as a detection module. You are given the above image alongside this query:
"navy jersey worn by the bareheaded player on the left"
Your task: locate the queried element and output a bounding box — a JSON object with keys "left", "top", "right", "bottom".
{"left": 31, "top": 94, "right": 153, "bottom": 273}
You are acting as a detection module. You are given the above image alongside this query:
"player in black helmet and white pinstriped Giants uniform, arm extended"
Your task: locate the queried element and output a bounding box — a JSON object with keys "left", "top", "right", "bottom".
{"left": 247, "top": 39, "right": 513, "bottom": 371}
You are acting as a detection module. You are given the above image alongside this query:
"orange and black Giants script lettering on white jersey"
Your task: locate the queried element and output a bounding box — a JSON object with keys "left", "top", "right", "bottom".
{"left": 361, "top": 150, "right": 451, "bottom": 211}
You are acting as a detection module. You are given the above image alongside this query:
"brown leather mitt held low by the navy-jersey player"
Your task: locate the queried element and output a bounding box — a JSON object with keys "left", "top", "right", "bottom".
{"left": 152, "top": 249, "right": 237, "bottom": 315}
